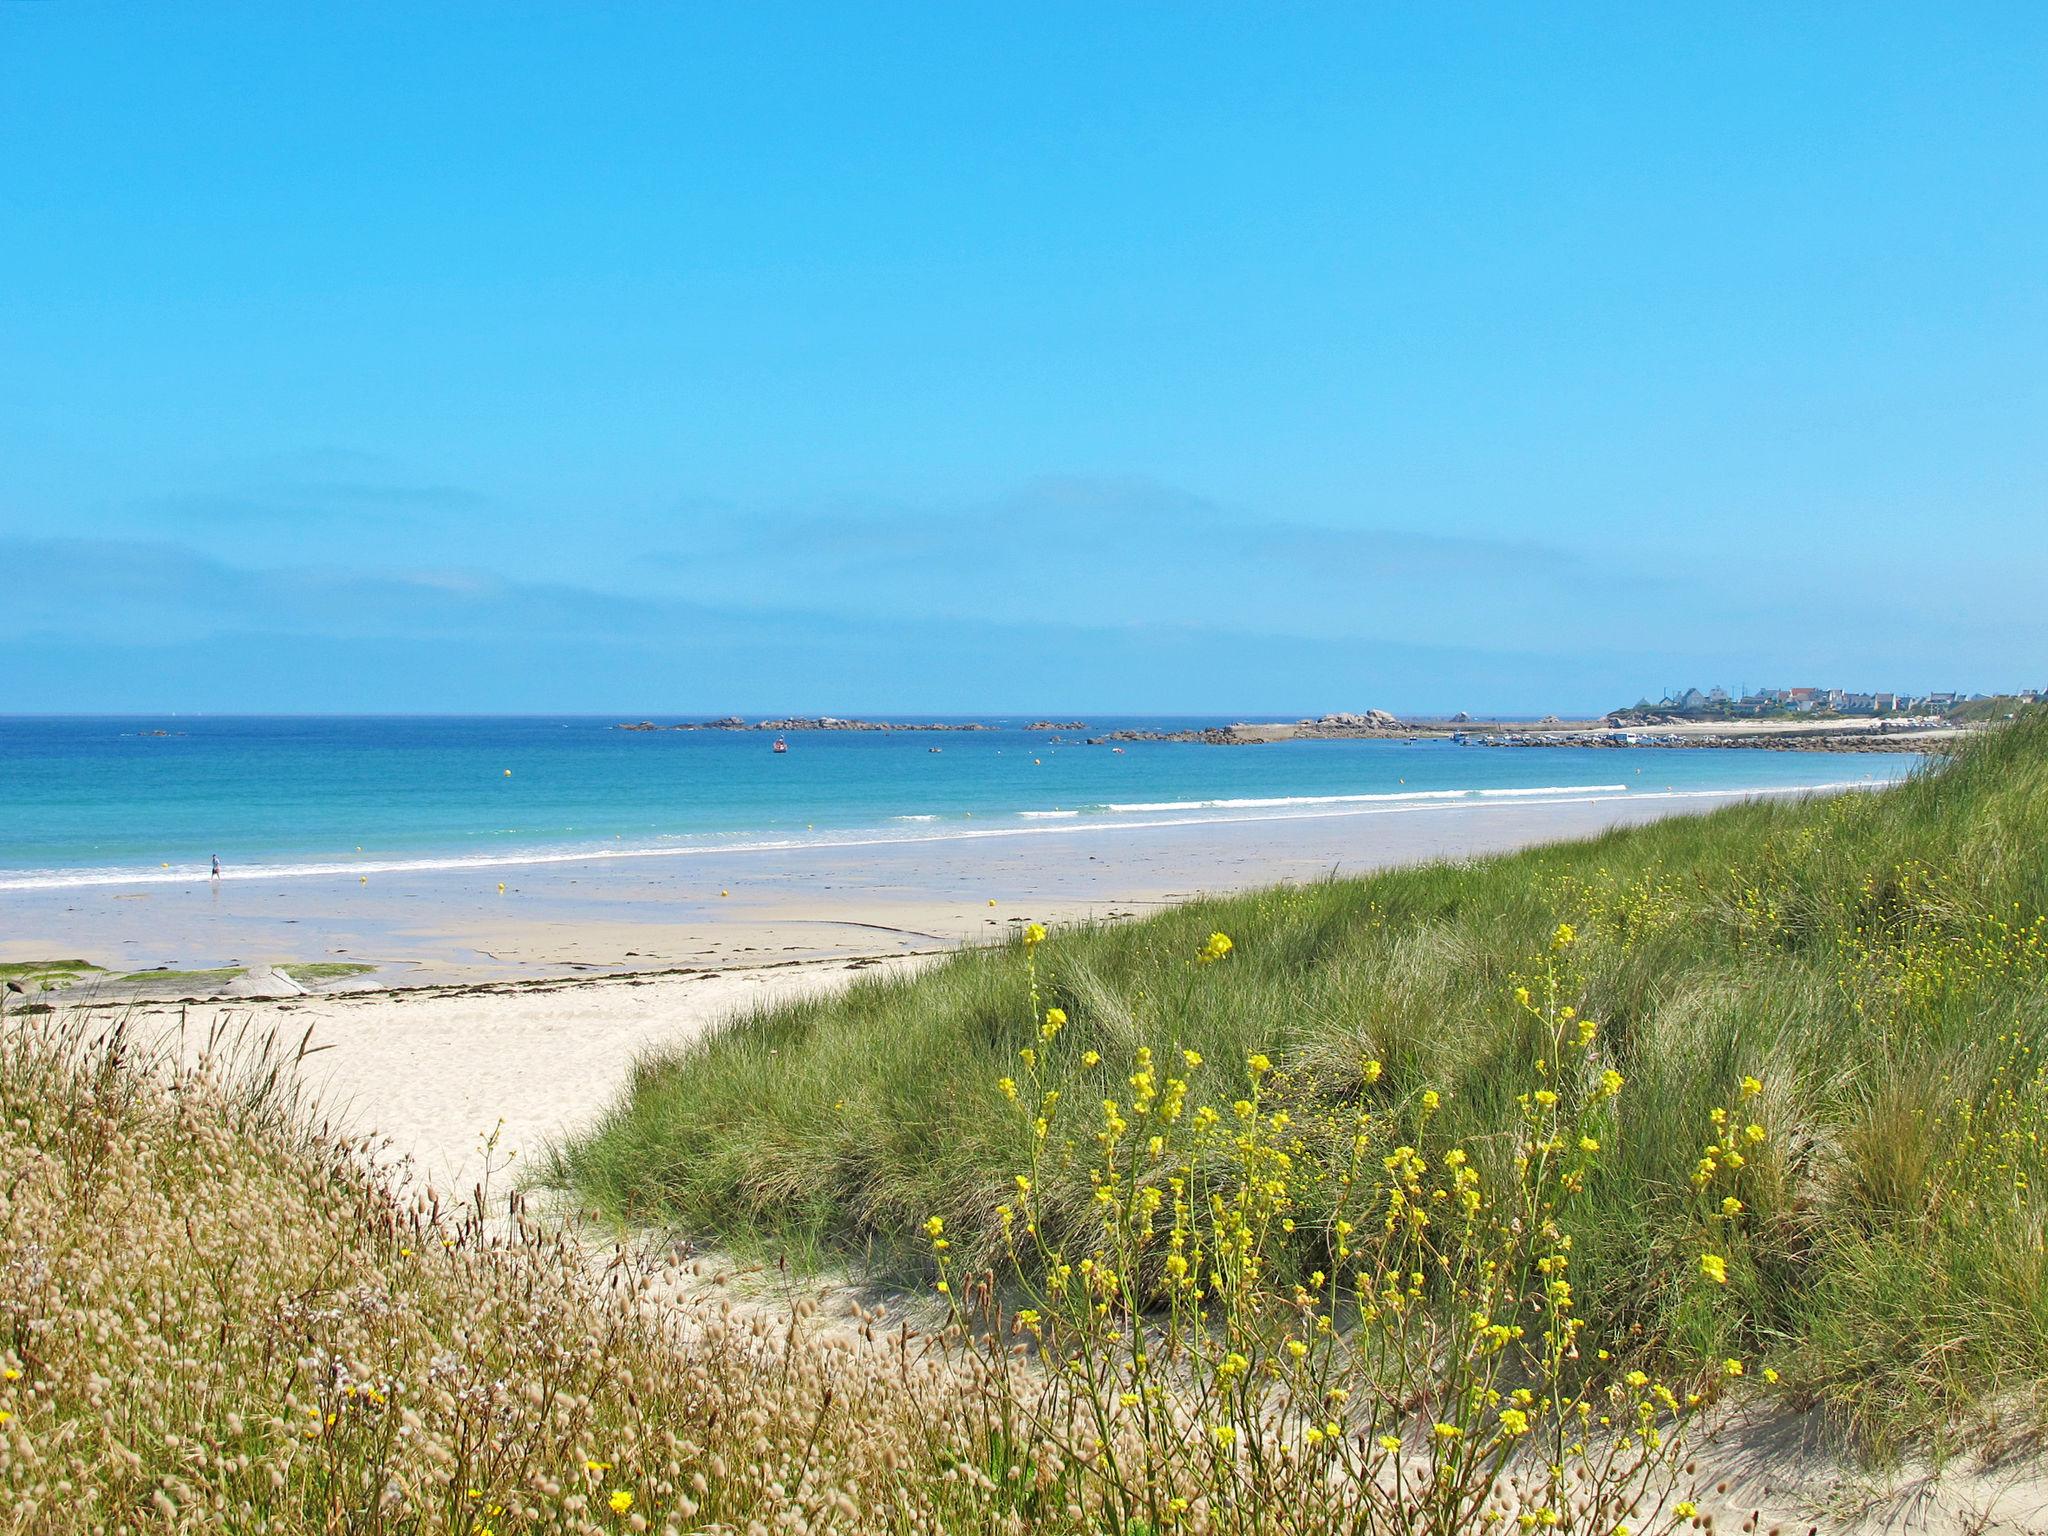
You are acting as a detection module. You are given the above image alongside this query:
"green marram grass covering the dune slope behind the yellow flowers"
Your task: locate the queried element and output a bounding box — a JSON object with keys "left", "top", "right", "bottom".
{"left": 549, "top": 711, "right": 2048, "bottom": 1452}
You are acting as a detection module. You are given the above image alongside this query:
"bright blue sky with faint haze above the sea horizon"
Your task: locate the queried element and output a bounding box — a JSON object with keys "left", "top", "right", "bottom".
{"left": 0, "top": 0, "right": 2048, "bottom": 715}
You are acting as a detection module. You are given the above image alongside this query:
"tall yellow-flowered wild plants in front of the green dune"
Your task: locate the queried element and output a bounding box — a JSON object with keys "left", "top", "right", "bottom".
{"left": 924, "top": 926, "right": 1728, "bottom": 1536}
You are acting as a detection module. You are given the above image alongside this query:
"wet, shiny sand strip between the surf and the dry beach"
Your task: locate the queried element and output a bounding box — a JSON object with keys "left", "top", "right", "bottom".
{"left": 0, "top": 782, "right": 1900, "bottom": 999}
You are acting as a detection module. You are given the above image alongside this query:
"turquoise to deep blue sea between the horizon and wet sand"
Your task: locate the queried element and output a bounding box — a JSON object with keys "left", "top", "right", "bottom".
{"left": 0, "top": 717, "right": 1917, "bottom": 891}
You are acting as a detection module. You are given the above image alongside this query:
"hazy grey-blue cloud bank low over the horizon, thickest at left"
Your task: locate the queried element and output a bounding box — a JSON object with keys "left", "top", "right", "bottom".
{"left": 0, "top": 541, "right": 1605, "bottom": 713}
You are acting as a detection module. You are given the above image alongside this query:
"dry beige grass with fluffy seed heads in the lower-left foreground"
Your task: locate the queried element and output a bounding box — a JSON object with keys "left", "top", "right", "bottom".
{"left": 0, "top": 1018, "right": 1056, "bottom": 1536}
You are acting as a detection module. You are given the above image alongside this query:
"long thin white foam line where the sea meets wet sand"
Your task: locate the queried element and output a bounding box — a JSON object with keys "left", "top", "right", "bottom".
{"left": 0, "top": 778, "right": 1892, "bottom": 893}
